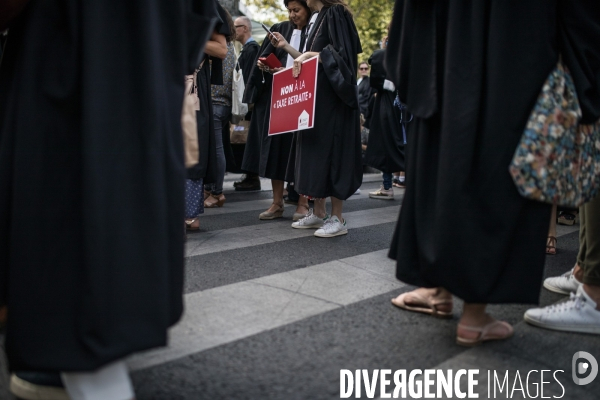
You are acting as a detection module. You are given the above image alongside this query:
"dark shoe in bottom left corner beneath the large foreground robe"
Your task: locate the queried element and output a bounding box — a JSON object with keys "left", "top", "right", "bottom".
{"left": 10, "top": 372, "right": 70, "bottom": 400}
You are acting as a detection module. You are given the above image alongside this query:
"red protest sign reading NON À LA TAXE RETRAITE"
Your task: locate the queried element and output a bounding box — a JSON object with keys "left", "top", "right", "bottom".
{"left": 269, "top": 56, "right": 319, "bottom": 135}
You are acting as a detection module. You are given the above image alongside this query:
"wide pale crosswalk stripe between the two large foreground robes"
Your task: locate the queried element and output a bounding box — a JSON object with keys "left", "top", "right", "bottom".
{"left": 128, "top": 250, "right": 404, "bottom": 370}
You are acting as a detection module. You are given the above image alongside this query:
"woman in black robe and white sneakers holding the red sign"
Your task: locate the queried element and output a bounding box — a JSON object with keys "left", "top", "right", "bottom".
{"left": 271, "top": 0, "right": 362, "bottom": 237}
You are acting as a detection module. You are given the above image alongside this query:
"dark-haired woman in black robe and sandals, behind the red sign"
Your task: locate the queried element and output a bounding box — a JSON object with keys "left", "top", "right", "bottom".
{"left": 242, "top": 0, "right": 310, "bottom": 221}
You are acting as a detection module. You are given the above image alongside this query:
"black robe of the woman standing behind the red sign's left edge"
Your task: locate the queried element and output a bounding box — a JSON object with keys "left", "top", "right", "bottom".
{"left": 242, "top": 21, "right": 294, "bottom": 180}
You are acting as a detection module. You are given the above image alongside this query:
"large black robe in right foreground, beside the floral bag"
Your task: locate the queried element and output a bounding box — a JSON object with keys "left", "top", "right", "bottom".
{"left": 386, "top": 0, "right": 600, "bottom": 303}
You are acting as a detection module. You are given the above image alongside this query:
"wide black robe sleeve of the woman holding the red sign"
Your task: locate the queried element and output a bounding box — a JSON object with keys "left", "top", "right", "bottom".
{"left": 317, "top": 5, "right": 362, "bottom": 109}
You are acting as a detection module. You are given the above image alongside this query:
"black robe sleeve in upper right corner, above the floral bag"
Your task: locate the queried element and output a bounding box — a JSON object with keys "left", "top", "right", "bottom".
{"left": 558, "top": 0, "right": 600, "bottom": 124}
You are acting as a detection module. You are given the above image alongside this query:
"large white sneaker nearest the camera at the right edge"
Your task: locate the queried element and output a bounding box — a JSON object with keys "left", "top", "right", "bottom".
{"left": 525, "top": 285, "right": 600, "bottom": 335}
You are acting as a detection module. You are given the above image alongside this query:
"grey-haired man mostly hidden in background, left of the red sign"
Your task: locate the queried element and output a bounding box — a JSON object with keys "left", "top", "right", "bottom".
{"left": 232, "top": 16, "right": 260, "bottom": 192}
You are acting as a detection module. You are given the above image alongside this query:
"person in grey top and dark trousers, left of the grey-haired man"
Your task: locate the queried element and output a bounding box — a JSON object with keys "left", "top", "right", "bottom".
{"left": 204, "top": 9, "right": 235, "bottom": 208}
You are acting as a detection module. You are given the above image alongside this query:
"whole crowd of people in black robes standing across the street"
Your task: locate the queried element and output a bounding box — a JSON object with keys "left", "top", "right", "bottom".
{"left": 0, "top": 0, "right": 600, "bottom": 399}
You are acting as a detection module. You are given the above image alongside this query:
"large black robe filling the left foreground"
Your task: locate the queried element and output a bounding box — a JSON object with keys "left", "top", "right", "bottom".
{"left": 0, "top": 0, "right": 214, "bottom": 371}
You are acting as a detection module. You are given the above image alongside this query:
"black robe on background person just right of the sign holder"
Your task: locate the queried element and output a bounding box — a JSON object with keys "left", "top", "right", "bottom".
{"left": 365, "top": 49, "right": 405, "bottom": 174}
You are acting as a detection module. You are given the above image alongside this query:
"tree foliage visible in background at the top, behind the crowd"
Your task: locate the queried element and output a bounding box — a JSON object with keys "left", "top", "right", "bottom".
{"left": 246, "top": 0, "right": 394, "bottom": 61}
